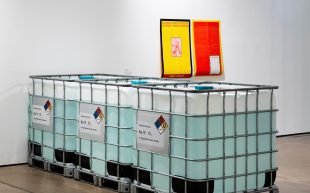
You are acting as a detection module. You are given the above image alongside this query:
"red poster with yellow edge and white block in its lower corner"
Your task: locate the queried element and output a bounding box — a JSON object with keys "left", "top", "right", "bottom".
{"left": 193, "top": 21, "right": 223, "bottom": 76}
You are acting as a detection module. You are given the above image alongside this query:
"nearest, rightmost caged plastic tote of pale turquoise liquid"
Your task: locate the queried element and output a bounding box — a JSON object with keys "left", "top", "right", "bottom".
{"left": 133, "top": 82, "right": 277, "bottom": 193}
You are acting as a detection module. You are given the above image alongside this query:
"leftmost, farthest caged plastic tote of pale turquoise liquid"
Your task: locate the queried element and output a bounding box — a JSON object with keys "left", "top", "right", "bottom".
{"left": 28, "top": 74, "right": 139, "bottom": 177}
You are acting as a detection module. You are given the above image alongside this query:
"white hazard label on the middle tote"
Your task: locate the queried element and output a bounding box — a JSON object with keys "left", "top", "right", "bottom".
{"left": 79, "top": 103, "right": 105, "bottom": 142}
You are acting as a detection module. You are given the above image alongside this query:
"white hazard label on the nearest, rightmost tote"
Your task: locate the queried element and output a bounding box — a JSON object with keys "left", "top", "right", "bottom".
{"left": 136, "top": 111, "right": 170, "bottom": 154}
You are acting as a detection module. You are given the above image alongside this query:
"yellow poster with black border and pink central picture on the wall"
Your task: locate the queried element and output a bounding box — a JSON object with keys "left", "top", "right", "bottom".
{"left": 160, "top": 19, "right": 192, "bottom": 78}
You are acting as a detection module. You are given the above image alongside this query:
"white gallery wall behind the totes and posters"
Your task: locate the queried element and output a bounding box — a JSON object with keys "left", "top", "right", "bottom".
{"left": 0, "top": 0, "right": 310, "bottom": 165}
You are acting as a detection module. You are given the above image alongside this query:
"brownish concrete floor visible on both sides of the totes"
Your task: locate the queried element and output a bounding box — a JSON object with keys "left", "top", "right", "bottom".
{"left": 0, "top": 135, "right": 310, "bottom": 193}
